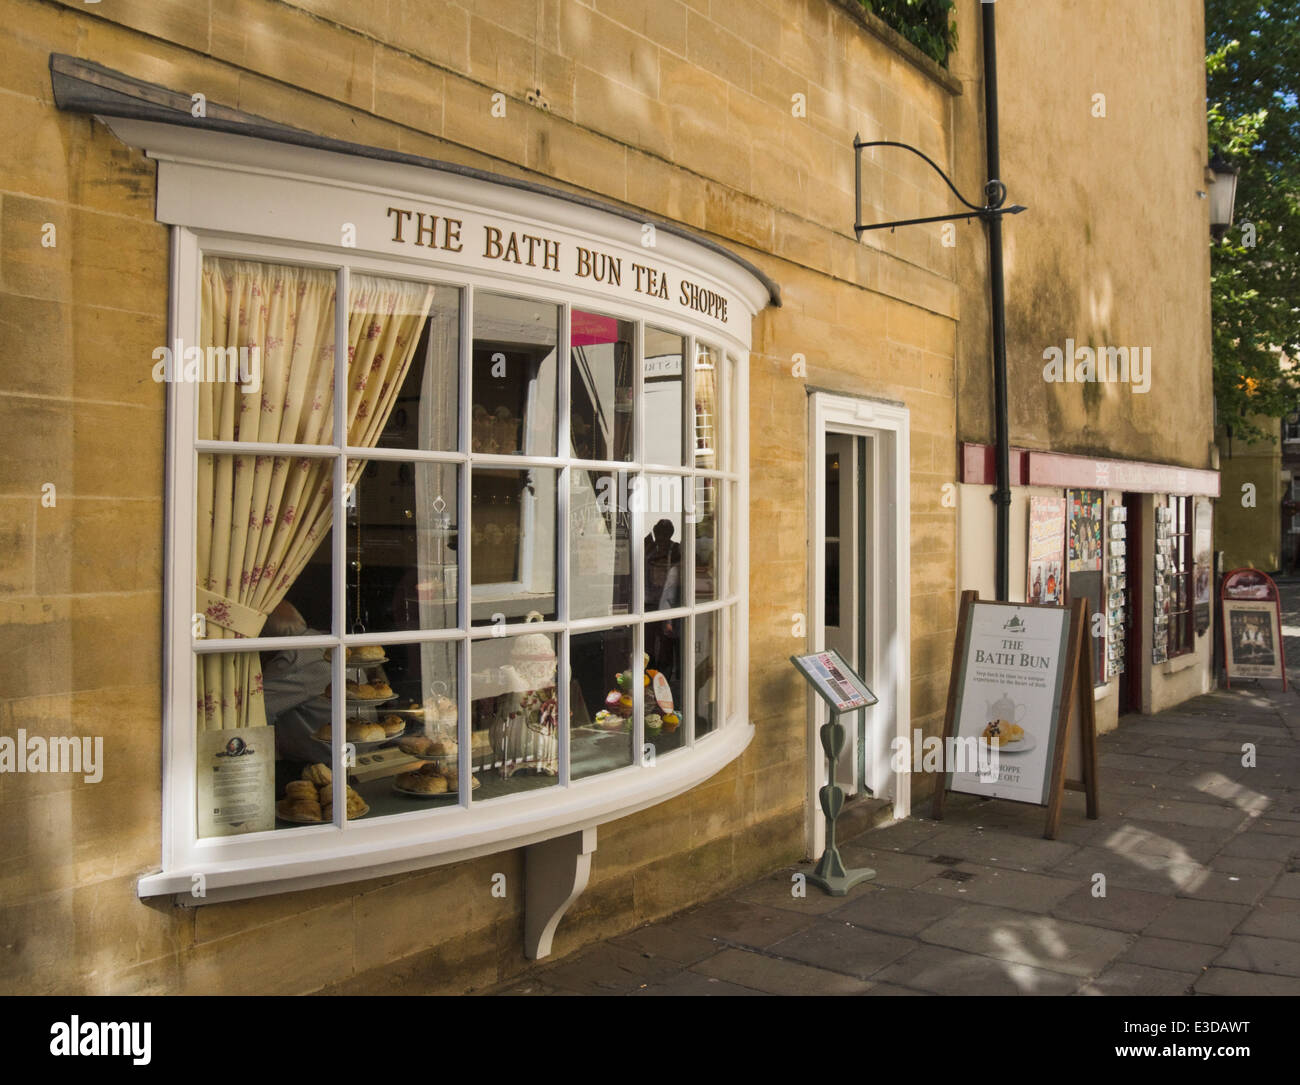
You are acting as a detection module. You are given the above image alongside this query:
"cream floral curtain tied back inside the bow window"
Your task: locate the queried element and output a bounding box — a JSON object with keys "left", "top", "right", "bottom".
{"left": 196, "top": 257, "right": 433, "bottom": 730}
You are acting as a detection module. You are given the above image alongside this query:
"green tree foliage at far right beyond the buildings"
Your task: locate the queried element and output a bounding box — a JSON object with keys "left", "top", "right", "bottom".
{"left": 1205, "top": 0, "right": 1300, "bottom": 440}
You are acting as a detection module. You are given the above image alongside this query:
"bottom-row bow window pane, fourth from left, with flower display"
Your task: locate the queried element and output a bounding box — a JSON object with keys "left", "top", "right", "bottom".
{"left": 569, "top": 629, "right": 634, "bottom": 780}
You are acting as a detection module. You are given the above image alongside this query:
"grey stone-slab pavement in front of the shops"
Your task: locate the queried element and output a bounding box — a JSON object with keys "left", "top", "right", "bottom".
{"left": 490, "top": 680, "right": 1300, "bottom": 995}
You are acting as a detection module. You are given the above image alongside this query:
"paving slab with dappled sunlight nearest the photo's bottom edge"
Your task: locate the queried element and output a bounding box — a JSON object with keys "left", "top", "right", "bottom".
{"left": 918, "top": 904, "right": 1128, "bottom": 976}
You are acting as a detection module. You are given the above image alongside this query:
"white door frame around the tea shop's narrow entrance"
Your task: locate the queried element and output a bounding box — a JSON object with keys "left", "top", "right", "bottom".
{"left": 805, "top": 391, "right": 911, "bottom": 858}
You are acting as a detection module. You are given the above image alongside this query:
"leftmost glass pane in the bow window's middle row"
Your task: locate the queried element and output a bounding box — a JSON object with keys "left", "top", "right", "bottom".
{"left": 195, "top": 453, "right": 335, "bottom": 638}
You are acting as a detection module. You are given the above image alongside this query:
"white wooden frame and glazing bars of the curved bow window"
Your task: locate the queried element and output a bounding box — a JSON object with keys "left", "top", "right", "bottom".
{"left": 113, "top": 121, "right": 766, "bottom": 903}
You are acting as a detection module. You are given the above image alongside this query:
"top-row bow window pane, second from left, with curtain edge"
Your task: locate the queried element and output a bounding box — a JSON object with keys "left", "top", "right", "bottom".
{"left": 366, "top": 275, "right": 460, "bottom": 452}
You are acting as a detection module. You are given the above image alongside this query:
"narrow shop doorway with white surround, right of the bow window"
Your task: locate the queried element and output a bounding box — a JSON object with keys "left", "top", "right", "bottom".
{"left": 806, "top": 392, "right": 911, "bottom": 855}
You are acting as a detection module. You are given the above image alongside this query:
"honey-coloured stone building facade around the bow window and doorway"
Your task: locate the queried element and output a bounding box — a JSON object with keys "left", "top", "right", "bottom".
{"left": 0, "top": 0, "right": 1210, "bottom": 993}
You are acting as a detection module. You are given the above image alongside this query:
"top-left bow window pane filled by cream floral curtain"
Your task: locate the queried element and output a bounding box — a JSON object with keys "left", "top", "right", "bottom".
{"left": 197, "top": 256, "right": 337, "bottom": 444}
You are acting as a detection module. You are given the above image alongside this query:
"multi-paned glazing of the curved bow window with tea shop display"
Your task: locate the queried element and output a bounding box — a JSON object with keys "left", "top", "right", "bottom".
{"left": 172, "top": 240, "right": 740, "bottom": 868}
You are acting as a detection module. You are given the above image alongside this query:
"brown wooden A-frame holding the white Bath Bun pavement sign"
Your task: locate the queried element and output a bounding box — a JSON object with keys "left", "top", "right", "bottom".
{"left": 932, "top": 591, "right": 1100, "bottom": 839}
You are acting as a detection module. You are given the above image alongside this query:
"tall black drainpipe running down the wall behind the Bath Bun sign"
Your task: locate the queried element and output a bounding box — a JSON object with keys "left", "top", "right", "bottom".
{"left": 980, "top": 4, "right": 1011, "bottom": 600}
